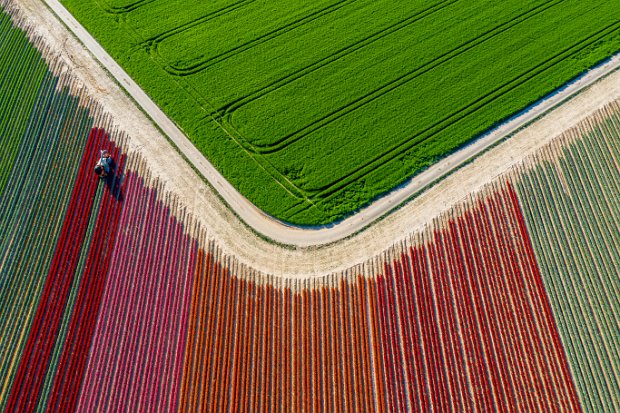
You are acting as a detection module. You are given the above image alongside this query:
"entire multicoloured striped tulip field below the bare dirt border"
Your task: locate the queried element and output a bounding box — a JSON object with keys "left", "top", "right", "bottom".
{"left": 0, "top": 4, "right": 620, "bottom": 412}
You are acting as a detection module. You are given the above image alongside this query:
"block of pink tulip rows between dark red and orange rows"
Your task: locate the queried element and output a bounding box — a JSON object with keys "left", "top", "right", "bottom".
{"left": 74, "top": 172, "right": 196, "bottom": 411}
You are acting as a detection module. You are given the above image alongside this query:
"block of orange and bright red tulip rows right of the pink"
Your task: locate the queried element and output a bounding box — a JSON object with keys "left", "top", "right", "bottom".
{"left": 174, "top": 187, "right": 580, "bottom": 412}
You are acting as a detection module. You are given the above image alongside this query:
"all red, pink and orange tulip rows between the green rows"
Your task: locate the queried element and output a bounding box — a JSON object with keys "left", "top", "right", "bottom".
{"left": 3, "top": 154, "right": 580, "bottom": 412}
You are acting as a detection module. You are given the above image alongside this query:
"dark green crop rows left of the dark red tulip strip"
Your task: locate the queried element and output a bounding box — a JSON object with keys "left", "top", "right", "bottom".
{"left": 0, "top": 8, "right": 93, "bottom": 410}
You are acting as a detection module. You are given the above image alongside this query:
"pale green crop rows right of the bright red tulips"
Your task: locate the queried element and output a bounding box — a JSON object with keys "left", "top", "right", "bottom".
{"left": 515, "top": 102, "right": 620, "bottom": 411}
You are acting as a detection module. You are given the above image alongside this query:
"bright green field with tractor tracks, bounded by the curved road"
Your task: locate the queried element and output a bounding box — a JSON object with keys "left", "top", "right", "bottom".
{"left": 62, "top": 0, "right": 620, "bottom": 225}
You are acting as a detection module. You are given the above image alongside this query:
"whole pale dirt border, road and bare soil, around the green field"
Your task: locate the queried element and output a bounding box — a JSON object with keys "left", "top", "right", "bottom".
{"left": 15, "top": 0, "right": 620, "bottom": 277}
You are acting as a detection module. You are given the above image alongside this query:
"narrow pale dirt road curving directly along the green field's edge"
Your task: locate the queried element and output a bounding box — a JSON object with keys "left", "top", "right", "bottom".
{"left": 45, "top": 0, "right": 620, "bottom": 247}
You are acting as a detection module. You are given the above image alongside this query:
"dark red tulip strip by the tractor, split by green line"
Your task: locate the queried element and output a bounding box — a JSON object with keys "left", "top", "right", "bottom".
{"left": 7, "top": 129, "right": 123, "bottom": 411}
